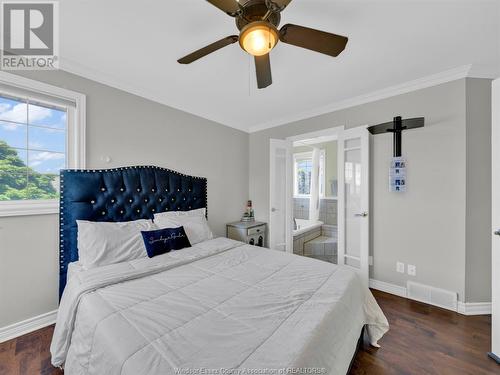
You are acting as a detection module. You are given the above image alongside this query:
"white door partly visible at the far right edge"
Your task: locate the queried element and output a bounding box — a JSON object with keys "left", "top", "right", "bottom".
{"left": 490, "top": 79, "right": 500, "bottom": 363}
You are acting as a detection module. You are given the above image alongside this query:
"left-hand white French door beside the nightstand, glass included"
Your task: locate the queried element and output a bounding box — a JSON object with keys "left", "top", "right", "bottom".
{"left": 269, "top": 139, "right": 293, "bottom": 252}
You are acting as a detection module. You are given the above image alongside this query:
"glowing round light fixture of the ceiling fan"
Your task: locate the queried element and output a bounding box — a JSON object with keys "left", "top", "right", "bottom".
{"left": 239, "top": 21, "right": 279, "bottom": 56}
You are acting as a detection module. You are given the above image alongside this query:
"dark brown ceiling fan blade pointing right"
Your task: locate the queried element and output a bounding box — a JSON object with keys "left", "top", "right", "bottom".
{"left": 280, "top": 23, "right": 348, "bottom": 57}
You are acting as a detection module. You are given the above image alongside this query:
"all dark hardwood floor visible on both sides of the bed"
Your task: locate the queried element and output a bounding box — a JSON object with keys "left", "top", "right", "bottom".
{"left": 0, "top": 291, "right": 500, "bottom": 375}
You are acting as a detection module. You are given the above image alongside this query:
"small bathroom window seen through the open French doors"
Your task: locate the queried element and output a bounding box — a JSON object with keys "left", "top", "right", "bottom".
{"left": 293, "top": 150, "right": 325, "bottom": 198}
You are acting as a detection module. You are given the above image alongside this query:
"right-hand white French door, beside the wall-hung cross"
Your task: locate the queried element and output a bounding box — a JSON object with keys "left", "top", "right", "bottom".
{"left": 337, "top": 127, "right": 370, "bottom": 286}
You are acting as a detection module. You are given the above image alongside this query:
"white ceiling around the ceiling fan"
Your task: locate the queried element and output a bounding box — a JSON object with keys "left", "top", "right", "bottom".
{"left": 60, "top": 0, "right": 500, "bottom": 131}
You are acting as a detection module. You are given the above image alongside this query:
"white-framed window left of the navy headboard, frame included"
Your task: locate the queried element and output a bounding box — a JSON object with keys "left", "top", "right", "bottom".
{"left": 0, "top": 73, "right": 85, "bottom": 216}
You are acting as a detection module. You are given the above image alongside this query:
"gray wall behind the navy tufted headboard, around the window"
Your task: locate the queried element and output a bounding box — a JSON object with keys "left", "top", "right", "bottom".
{"left": 0, "top": 71, "right": 249, "bottom": 327}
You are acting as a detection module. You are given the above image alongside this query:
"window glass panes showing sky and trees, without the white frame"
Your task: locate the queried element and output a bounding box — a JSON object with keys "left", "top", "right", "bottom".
{"left": 0, "top": 94, "right": 67, "bottom": 201}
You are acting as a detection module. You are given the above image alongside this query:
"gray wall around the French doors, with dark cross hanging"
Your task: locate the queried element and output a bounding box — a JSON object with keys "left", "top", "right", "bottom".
{"left": 250, "top": 79, "right": 490, "bottom": 302}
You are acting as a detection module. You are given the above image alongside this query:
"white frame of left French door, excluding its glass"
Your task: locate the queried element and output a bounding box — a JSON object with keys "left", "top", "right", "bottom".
{"left": 268, "top": 139, "right": 293, "bottom": 253}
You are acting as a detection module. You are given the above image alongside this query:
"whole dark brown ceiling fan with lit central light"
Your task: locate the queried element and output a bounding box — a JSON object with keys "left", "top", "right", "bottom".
{"left": 177, "top": 0, "right": 348, "bottom": 89}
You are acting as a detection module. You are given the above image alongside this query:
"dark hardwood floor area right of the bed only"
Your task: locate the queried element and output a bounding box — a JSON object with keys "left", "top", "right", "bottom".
{"left": 351, "top": 290, "right": 500, "bottom": 375}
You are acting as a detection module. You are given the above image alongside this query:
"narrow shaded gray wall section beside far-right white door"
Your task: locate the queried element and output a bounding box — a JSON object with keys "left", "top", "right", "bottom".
{"left": 465, "top": 78, "right": 491, "bottom": 302}
